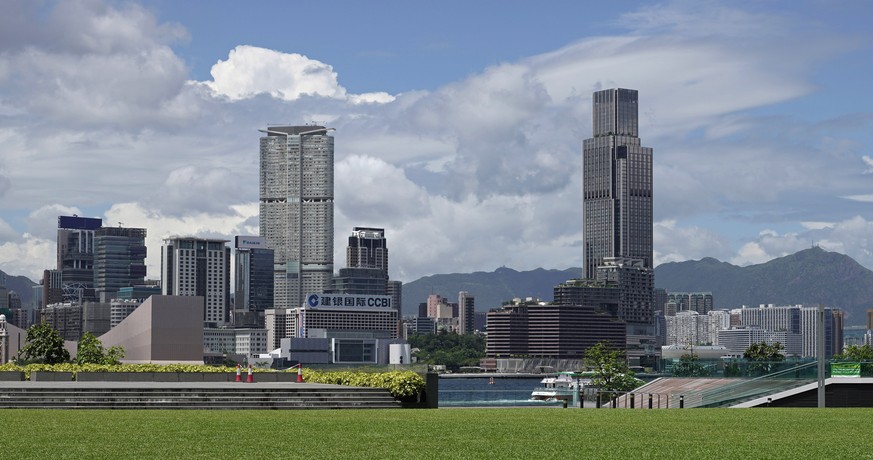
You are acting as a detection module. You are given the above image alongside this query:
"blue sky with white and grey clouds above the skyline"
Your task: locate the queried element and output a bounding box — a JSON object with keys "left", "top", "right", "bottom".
{"left": 0, "top": 0, "right": 873, "bottom": 294}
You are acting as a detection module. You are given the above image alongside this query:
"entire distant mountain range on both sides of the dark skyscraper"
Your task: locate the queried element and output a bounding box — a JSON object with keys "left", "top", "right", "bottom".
{"left": 403, "top": 247, "right": 873, "bottom": 325}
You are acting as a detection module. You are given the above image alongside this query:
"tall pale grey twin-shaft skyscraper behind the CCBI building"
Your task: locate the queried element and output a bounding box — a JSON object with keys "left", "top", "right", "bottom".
{"left": 260, "top": 126, "right": 334, "bottom": 308}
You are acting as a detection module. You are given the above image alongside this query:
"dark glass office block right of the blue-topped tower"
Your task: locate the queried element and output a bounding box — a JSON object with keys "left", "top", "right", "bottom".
{"left": 94, "top": 227, "right": 146, "bottom": 302}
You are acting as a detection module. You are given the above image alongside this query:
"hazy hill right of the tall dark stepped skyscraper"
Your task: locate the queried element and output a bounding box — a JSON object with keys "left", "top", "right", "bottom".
{"left": 655, "top": 247, "right": 873, "bottom": 325}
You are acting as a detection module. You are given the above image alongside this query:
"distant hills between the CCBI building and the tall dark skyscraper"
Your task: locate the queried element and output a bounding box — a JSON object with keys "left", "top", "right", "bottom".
{"left": 403, "top": 267, "right": 582, "bottom": 315}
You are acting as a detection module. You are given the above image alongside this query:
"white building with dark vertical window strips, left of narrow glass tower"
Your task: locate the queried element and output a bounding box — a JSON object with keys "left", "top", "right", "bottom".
{"left": 161, "top": 236, "right": 230, "bottom": 325}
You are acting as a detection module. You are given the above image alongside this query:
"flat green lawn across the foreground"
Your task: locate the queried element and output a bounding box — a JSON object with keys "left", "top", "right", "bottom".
{"left": 0, "top": 408, "right": 873, "bottom": 460}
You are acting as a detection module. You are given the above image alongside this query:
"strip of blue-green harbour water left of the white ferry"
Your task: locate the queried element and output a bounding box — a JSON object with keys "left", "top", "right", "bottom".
{"left": 439, "top": 374, "right": 563, "bottom": 407}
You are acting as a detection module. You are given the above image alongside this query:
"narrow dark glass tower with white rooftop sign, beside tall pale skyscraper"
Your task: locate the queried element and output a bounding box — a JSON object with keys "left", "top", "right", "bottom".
{"left": 233, "top": 236, "right": 275, "bottom": 327}
